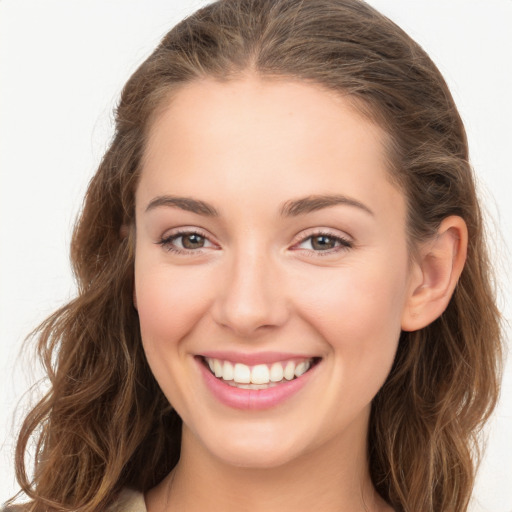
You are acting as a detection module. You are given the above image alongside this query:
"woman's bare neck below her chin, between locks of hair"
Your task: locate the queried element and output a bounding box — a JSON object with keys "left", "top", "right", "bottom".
{"left": 146, "top": 420, "right": 391, "bottom": 512}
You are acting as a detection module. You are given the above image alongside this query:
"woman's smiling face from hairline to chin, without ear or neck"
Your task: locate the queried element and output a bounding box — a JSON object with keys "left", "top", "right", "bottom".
{"left": 135, "top": 78, "right": 411, "bottom": 467}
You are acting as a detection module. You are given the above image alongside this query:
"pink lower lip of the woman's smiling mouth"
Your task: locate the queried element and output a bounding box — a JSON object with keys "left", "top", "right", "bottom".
{"left": 197, "top": 360, "right": 317, "bottom": 410}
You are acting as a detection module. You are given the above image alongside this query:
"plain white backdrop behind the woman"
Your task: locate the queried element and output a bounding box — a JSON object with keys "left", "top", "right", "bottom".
{"left": 0, "top": 0, "right": 512, "bottom": 512}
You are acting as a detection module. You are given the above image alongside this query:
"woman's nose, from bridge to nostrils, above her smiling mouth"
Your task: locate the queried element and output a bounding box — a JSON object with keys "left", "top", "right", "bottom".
{"left": 213, "top": 250, "right": 289, "bottom": 338}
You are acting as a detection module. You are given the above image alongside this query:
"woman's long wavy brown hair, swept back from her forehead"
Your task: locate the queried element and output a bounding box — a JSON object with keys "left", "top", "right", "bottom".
{"left": 10, "top": 0, "right": 501, "bottom": 512}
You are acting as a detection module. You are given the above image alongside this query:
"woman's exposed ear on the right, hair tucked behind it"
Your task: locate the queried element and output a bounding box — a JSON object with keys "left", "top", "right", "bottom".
{"left": 402, "top": 216, "right": 468, "bottom": 331}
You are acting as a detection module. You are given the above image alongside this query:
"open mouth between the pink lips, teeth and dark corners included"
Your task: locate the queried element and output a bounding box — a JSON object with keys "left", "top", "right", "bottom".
{"left": 199, "top": 356, "right": 321, "bottom": 390}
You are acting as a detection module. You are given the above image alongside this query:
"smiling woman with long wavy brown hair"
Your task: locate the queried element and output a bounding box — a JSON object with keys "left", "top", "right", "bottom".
{"left": 2, "top": 0, "right": 500, "bottom": 512}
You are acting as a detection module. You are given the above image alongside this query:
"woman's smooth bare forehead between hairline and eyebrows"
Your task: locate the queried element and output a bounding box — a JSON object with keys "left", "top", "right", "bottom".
{"left": 138, "top": 78, "right": 401, "bottom": 221}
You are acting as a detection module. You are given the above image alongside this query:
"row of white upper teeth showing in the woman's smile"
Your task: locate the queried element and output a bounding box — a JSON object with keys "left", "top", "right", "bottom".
{"left": 205, "top": 357, "right": 312, "bottom": 384}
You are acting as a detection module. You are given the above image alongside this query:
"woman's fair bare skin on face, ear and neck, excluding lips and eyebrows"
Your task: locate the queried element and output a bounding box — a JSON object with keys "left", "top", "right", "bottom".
{"left": 134, "top": 77, "right": 466, "bottom": 512}
